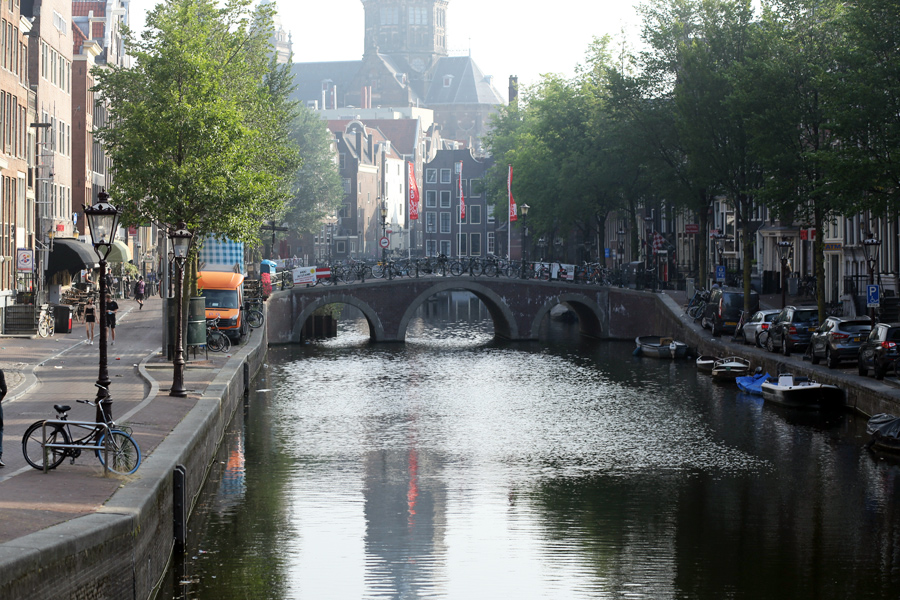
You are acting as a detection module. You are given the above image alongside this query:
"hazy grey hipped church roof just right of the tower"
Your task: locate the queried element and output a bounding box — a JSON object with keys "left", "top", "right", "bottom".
{"left": 425, "top": 56, "right": 503, "bottom": 106}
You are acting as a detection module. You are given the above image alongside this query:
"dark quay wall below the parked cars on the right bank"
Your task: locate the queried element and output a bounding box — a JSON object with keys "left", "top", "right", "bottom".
{"left": 648, "top": 292, "right": 900, "bottom": 416}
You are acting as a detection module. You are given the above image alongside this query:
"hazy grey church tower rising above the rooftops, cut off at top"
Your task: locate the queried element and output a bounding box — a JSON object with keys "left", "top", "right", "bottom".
{"left": 362, "top": 0, "right": 448, "bottom": 73}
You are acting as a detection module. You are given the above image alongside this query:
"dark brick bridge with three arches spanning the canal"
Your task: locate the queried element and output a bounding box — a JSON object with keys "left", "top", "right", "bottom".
{"left": 266, "top": 276, "right": 672, "bottom": 344}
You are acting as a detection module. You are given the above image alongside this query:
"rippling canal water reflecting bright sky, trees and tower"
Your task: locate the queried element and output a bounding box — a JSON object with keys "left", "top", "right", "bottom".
{"left": 167, "top": 294, "right": 900, "bottom": 600}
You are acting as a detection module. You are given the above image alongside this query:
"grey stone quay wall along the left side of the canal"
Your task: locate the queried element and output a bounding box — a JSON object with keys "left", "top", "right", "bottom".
{"left": 0, "top": 328, "right": 268, "bottom": 600}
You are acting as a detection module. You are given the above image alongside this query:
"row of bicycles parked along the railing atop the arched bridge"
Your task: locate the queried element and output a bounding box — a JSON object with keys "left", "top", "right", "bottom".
{"left": 298, "top": 254, "right": 626, "bottom": 286}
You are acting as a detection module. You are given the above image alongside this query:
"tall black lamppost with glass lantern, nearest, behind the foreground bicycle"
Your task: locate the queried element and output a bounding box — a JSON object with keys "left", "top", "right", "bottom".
{"left": 84, "top": 189, "right": 121, "bottom": 423}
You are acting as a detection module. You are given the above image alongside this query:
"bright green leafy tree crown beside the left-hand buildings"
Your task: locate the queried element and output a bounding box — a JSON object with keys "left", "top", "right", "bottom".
{"left": 94, "top": 0, "right": 300, "bottom": 242}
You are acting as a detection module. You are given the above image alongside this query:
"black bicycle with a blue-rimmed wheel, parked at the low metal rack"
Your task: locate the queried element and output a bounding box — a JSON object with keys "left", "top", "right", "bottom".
{"left": 22, "top": 383, "right": 141, "bottom": 475}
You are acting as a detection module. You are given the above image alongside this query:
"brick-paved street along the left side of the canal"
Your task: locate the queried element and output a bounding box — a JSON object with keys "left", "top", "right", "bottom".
{"left": 0, "top": 296, "right": 236, "bottom": 544}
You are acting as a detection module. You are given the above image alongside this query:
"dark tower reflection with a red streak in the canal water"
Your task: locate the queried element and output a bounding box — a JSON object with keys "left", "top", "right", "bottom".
{"left": 364, "top": 441, "right": 447, "bottom": 598}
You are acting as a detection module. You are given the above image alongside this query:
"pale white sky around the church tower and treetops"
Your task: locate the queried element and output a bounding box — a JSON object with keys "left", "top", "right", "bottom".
{"left": 131, "top": 0, "right": 640, "bottom": 91}
